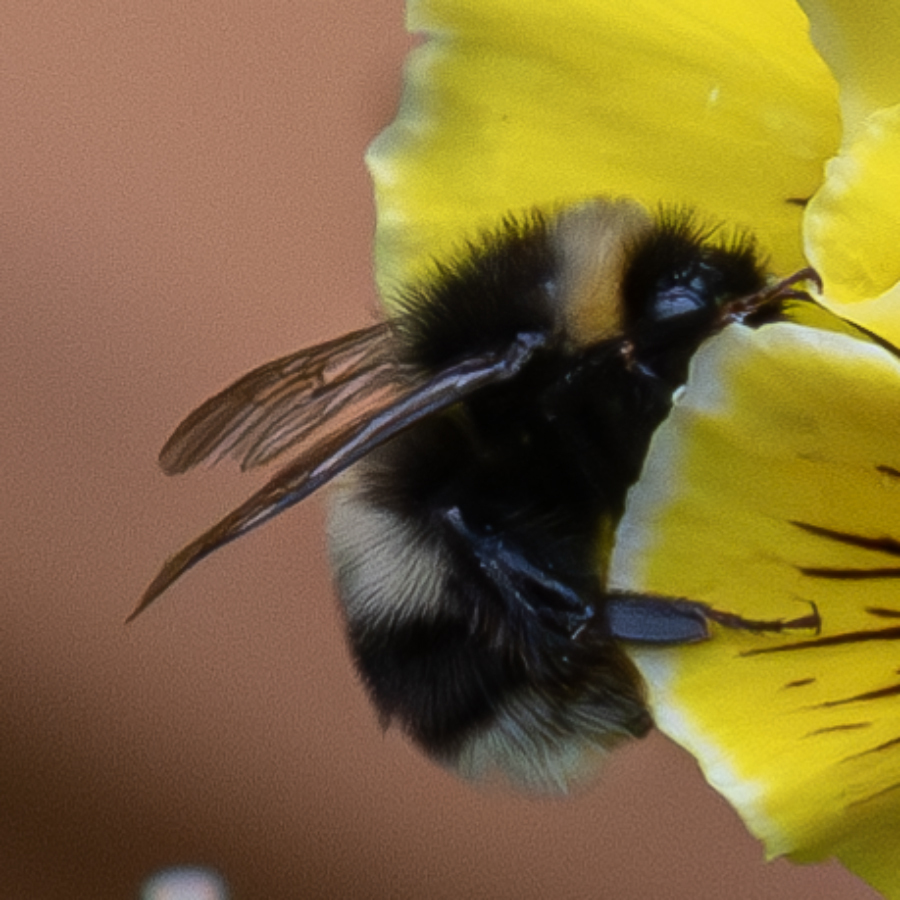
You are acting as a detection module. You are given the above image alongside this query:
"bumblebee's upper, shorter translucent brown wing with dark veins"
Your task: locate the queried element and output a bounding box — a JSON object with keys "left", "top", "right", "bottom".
{"left": 159, "top": 324, "right": 397, "bottom": 475}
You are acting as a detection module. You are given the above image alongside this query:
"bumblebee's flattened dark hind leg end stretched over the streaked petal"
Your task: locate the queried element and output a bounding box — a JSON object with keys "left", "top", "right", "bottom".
{"left": 604, "top": 593, "right": 822, "bottom": 644}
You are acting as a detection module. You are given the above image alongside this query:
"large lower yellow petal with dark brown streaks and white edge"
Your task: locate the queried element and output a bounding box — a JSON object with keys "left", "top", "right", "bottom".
{"left": 611, "top": 324, "right": 900, "bottom": 896}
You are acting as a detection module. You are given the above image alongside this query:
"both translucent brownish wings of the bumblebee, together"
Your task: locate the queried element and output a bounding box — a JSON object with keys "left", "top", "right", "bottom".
{"left": 129, "top": 326, "right": 545, "bottom": 621}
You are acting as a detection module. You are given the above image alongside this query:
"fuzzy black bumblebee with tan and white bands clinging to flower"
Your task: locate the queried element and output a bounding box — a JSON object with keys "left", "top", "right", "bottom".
{"left": 132, "top": 198, "right": 814, "bottom": 789}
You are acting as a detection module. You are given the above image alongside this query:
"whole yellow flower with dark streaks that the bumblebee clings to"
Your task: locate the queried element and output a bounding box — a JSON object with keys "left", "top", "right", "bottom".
{"left": 369, "top": 0, "right": 900, "bottom": 897}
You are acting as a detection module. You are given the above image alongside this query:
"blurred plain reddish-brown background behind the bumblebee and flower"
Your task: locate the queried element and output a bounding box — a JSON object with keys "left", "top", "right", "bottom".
{"left": 0, "top": 0, "right": 884, "bottom": 900}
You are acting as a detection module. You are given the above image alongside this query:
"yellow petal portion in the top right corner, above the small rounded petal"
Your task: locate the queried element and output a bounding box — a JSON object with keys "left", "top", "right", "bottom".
{"left": 800, "top": 0, "right": 900, "bottom": 144}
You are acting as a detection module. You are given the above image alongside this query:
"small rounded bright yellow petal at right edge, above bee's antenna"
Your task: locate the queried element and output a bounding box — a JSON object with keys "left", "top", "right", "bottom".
{"left": 804, "top": 101, "right": 900, "bottom": 343}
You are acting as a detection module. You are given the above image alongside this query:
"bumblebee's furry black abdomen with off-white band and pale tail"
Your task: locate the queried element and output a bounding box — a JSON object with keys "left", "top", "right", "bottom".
{"left": 331, "top": 459, "right": 650, "bottom": 789}
